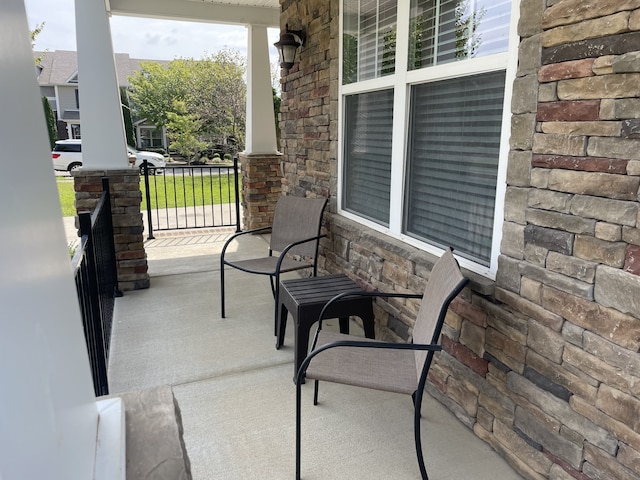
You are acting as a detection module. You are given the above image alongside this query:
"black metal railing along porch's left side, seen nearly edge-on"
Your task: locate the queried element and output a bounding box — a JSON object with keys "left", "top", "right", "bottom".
{"left": 71, "top": 178, "right": 122, "bottom": 396}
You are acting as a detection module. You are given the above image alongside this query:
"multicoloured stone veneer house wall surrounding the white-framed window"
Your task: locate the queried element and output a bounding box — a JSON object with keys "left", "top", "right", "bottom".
{"left": 281, "top": 0, "right": 640, "bottom": 480}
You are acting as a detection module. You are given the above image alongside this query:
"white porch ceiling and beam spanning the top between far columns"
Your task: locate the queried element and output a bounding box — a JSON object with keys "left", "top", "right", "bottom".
{"left": 105, "top": 0, "right": 280, "bottom": 28}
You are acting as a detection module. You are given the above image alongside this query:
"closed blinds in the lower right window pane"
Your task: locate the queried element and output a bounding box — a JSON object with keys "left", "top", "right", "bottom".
{"left": 405, "top": 71, "right": 505, "bottom": 265}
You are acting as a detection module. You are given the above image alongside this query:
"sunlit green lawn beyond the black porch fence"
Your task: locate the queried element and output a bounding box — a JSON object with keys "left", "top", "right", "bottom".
{"left": 56, "top": 175, "right": 235, "bottom": 217}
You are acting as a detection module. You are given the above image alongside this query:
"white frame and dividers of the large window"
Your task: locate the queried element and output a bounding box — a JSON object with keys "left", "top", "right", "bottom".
{"left": 337, "top": 0, "right": 520, "bottom": 280}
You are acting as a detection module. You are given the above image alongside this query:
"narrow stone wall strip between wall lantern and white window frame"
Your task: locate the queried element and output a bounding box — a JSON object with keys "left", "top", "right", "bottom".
{"left": 280, "top": 0, "right": 339, "bottom": 210}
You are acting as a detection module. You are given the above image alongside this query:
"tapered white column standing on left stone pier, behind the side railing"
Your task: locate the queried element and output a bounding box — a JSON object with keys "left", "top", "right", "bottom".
{"left": 75, "top": 0, "right": 129, "bottom": 170}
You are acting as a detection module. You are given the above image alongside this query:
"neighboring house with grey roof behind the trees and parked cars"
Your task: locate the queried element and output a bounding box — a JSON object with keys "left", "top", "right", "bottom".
{"left": 34, "top": 50, "right": 167, "bottom": 149}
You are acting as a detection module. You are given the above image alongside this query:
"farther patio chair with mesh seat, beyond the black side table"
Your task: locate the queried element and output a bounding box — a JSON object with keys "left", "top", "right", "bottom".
{"left": 220, "top": 196, "right": 327, "bottom": 335}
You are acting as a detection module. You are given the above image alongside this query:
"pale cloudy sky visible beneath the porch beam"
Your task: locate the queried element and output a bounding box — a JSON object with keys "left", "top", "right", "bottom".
{"left": 24, "top": 0, "right": 279, "bottom": 63}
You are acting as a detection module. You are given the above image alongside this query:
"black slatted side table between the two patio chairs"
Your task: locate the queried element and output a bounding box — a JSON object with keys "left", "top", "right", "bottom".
{"left": 276, "top": 275, "right": 375, "bottom": 381}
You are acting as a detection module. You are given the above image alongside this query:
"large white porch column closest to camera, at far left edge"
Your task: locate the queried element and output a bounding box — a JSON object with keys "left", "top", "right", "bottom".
{"left": 0, "top": 0, "right": 98, "bottom": 480}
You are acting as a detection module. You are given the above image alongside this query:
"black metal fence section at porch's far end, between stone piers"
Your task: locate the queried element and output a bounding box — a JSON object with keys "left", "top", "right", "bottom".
{"left": 141, "top": 157, "right": 240, "bottom": 239}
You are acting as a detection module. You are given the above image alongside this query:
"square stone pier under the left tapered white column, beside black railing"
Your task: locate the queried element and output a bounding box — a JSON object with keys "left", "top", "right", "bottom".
{"left": 73, "top": 168, "right": 150, "bottom": 291}
